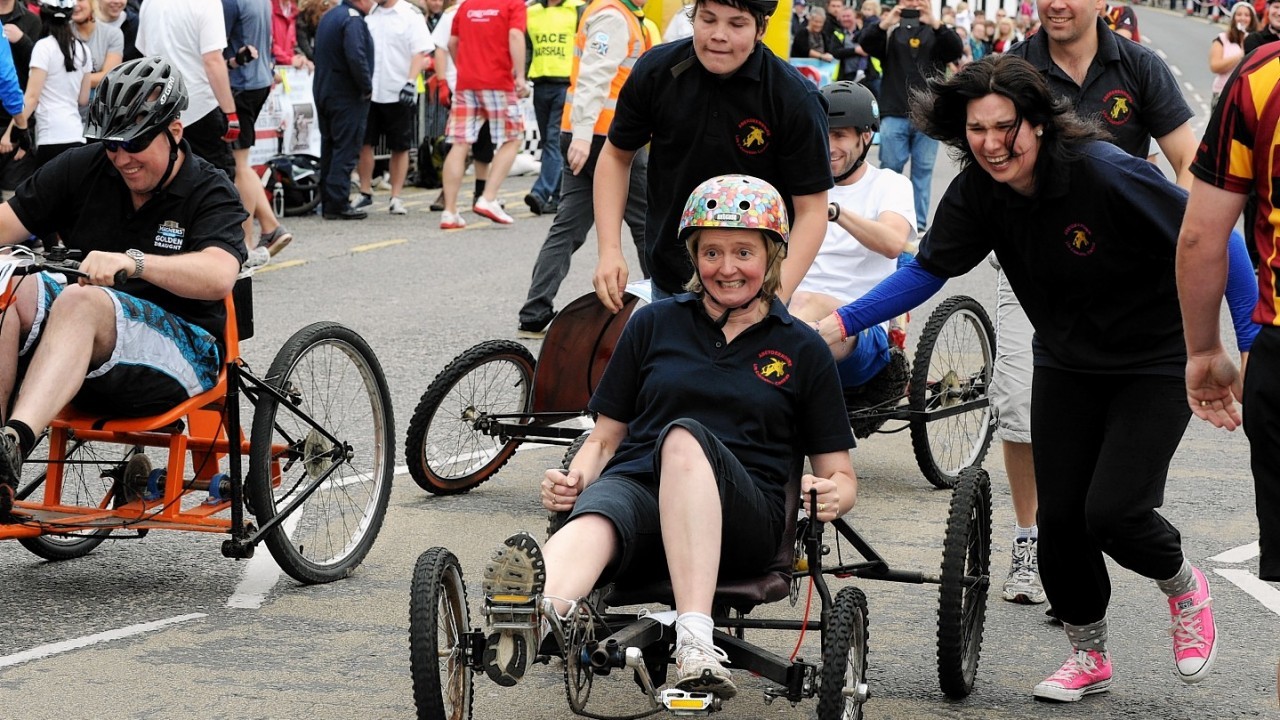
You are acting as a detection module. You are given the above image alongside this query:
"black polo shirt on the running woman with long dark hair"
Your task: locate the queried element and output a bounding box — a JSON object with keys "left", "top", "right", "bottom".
{"left": 916, "top": 142, "right": 1187, "bottom": 377}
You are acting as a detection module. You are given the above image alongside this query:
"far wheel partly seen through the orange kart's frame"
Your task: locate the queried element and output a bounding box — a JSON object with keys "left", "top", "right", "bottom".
{"left": 17, "top": 438, "right": 151, "bottom": 560}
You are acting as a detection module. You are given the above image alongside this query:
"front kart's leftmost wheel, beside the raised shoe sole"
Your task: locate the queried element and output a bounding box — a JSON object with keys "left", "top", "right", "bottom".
{"left": 408, "top": 547, "right": 472, "bottom": 720}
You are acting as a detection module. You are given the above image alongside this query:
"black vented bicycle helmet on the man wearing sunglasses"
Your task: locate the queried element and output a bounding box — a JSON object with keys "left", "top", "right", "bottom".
{"left": 85, "top": 58, "right": 187, "bottom": 142}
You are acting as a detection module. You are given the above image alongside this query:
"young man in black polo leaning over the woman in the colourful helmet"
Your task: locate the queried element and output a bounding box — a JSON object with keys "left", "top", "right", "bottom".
{"left": 594, "top": 0, "right": 832, "bottom": 311}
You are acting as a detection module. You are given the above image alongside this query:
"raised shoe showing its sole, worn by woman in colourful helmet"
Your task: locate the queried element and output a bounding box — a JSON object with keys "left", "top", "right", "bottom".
{"left": 481, "top": 532, "right": 547, "bottom": 687}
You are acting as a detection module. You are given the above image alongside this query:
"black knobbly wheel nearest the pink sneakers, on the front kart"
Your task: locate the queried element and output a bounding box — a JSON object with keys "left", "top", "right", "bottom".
{"left": 938, "top": 468, "right": 991, "bottom": 698}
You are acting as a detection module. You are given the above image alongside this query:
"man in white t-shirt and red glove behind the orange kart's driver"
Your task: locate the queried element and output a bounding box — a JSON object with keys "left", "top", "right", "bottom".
{"left": 137, "top": 0, "right": 240, "bottom": 175}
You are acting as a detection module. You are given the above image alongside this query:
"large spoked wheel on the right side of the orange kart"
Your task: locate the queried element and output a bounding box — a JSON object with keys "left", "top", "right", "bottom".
{"left": 247, "top": 323, "right": 396, "bottom": 584}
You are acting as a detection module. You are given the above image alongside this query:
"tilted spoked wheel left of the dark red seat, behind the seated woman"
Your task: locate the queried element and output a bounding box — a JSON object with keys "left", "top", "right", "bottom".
{"left": 404, "top": 340, "right": 534, "bottom": 495}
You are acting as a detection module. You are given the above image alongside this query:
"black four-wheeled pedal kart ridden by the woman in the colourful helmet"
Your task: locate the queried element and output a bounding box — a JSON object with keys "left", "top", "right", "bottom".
{"left": 410, "top": 448, "right": 991, "bottom": 720}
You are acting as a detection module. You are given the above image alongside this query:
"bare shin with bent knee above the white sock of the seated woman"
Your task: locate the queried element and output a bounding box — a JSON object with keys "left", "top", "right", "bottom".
{"left": 658, "top": 428, "right": 723, "bottom": 615}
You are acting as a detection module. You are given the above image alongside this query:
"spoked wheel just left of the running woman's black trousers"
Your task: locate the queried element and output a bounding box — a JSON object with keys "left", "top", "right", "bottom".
{"left": 908, "top": 296, "right": 996, "bottom": 488}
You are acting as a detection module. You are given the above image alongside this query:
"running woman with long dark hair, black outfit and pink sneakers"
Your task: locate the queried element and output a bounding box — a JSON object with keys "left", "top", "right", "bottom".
{"left": 818, "top": 55, "right": 1257, "bottom": 702}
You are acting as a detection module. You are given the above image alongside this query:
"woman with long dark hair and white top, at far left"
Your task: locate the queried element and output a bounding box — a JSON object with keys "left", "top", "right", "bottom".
{"left": 0, "top": 0, "right": 92, "bottom": 167}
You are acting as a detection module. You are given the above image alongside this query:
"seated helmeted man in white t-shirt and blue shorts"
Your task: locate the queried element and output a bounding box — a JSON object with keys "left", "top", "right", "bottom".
{"left": 790, "top": 81, "right": 915, "bottom": 387}
